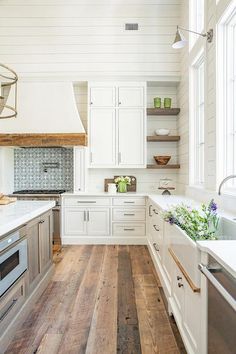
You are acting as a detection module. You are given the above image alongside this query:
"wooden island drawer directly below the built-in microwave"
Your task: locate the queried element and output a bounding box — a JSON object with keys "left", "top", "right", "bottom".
{"left": 0, "top": 276, "right": 25, "bottom": 333}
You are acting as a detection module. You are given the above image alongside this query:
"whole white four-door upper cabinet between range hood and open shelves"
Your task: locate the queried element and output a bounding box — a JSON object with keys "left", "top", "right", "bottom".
{"left": 88, "top": 82, "right": 146, "bottom": 168}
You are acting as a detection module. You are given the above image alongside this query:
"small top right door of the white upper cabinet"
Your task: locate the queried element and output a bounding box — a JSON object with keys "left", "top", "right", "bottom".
{"left": 118, "top": 86, "right": 145, "bottom": 108}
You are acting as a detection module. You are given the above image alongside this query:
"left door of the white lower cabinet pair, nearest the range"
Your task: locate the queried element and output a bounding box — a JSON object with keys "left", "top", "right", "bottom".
{"left": 64, "top": 208, "right": 87, "bottom": 236}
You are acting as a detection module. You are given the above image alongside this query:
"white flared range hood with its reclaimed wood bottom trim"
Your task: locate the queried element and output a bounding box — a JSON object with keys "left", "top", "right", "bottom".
{"left": 0, "top": 82, "right": 87, "bottom": 147}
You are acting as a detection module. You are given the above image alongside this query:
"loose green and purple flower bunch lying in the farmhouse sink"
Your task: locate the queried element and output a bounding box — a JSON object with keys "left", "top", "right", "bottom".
{"left": 163, "top": 199, "right": 219, "bottom": 241}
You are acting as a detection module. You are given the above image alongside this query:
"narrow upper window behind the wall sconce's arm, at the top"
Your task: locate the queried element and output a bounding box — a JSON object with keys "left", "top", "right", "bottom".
{"left": 190, "top": 0, "right": 205, "bottom": 46}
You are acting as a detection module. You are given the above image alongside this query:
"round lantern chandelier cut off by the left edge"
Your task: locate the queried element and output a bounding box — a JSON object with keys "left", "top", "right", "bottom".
{"left": 0, "top": 63, "right": 18, "bottom": 119}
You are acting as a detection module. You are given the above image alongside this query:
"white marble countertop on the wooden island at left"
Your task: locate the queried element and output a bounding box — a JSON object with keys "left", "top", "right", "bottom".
{"left": 0, "top": 200, "right": 55, "bottom": 237}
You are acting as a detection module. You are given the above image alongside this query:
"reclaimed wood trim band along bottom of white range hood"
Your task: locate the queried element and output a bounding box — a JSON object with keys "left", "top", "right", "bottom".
{"left": 0, "top": 133, "right": 87, "bottom": 147}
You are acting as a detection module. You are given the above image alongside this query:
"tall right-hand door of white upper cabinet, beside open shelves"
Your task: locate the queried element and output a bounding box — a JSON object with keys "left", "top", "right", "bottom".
{"left": 118, "top": 109, "right": 145, "bottom": 168}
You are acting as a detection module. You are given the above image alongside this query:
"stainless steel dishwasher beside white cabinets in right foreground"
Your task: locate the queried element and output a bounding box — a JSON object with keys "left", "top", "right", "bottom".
{"left": 199, "top": 256, "right": 236, "bottom": 354}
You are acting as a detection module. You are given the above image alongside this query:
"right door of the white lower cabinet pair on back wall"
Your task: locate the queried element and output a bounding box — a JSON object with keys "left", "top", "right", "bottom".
{"left": 87, "top": 208, "right": 110, "bottom": 236}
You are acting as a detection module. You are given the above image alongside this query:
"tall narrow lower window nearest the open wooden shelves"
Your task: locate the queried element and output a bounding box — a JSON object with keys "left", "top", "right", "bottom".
{"left": 190, "top": 55, "right": 205, "bottom": 186}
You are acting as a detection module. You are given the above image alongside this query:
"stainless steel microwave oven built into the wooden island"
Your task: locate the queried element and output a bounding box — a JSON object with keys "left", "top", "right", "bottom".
{"left": 0, "top": 227, "right": 27, "bottom": 296}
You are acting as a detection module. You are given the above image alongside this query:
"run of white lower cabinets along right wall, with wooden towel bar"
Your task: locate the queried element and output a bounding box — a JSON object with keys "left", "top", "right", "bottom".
{"left": 147, "top": 200, "right": 206, "bottom": 354}
